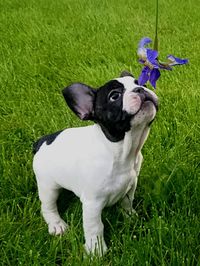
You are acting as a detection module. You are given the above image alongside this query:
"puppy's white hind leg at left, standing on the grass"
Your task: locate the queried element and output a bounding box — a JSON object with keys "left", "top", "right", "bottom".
{"left": 38, "top": 182, "right": 67, "bottom": 235}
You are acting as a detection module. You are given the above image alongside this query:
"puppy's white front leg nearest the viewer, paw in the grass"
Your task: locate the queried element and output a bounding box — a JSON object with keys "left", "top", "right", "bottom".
{"left": 83, "top": 201, "right": 107, "bottom": 256}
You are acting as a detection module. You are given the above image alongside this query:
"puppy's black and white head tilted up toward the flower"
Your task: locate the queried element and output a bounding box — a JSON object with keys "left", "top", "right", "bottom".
{"left": 63, "top": 72, "right": 158, "bottom": 142}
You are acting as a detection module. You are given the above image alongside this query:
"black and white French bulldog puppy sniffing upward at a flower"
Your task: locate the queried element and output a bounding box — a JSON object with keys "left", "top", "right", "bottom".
{"left": 33, "top": 70, "right": 158, "bottom": 255}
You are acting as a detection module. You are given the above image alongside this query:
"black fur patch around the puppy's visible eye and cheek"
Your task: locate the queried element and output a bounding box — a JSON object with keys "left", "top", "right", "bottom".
{"left": 94, "top": 80, "right": 132, "bottom": 142}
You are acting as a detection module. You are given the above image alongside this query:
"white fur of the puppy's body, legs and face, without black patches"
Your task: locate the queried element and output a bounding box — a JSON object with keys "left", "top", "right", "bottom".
{"left": 33, "top": 77, "right": 157, "bottom": 255}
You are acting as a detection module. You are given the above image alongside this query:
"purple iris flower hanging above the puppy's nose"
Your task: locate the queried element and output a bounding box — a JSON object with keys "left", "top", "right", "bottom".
{"left": 138, "top": 37, "right": 188, "bottom": 88}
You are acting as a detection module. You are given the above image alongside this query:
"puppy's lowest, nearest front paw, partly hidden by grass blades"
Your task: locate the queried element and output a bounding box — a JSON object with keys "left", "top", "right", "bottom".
{"left": 84, "top": 240, "right": 108, "bottom": 257}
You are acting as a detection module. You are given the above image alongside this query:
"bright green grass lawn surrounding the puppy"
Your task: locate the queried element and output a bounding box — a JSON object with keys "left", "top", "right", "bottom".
{"left": 0, "top": 0, "right": 200, "bottom": 266}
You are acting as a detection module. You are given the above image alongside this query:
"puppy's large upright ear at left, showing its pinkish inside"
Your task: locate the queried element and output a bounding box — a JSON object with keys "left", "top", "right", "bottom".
{"left": 62, "top": 83, "right": 96, "bottom": 120}
